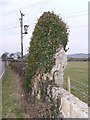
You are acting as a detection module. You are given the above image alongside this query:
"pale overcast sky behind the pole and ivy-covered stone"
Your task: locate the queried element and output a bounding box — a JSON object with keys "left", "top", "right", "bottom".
{"left": 0, "top": 0, "right": 88, "bottom": 55}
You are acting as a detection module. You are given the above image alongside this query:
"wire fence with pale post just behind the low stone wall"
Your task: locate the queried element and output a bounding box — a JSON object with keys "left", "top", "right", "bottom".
{"left": 64, "top": 77, "right": 90, "bottom": 106}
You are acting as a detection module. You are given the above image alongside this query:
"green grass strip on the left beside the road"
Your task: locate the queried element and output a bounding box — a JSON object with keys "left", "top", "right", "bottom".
{"left": 2, "top": 66, "right": 23, "bottom": 118}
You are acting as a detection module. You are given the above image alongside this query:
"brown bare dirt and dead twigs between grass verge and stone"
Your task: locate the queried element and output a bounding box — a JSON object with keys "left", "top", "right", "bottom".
{"left": 17, "top": 72, "right": 51, "bottom": 118}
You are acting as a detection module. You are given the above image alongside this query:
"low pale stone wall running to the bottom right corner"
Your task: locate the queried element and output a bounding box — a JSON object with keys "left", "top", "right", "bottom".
{"left": 52, "top": 87, "right": 89, "bottom": 118}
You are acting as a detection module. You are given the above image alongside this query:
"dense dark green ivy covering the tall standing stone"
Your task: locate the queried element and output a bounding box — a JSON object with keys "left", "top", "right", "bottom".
{"left": 25, "top": 12, "right": 69, "bottom": 90}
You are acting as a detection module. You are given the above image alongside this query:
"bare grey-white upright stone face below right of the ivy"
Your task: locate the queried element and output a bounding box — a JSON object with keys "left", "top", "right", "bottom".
{"left": 51, "top": 48, "right": 67, "bottom": 87}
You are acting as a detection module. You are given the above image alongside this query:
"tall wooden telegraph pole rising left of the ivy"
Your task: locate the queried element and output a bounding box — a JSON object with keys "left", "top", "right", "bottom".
{"left": 20, "top": 11, "right": 24, "bottom": 62}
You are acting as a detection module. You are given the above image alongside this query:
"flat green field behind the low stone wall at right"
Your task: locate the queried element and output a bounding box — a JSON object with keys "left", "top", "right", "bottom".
{"left": 64, "top": 61, "right": 88, "bottom": 103}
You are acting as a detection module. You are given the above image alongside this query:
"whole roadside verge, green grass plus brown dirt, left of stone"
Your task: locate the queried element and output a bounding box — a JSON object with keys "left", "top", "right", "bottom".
{"left": 2, "top": 66, "right": 51, "bottom": 118}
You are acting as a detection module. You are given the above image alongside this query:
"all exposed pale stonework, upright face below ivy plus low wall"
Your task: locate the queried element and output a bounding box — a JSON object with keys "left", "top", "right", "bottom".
{"left": 32, "top": 48, "right": 88, "bottom": 118}
